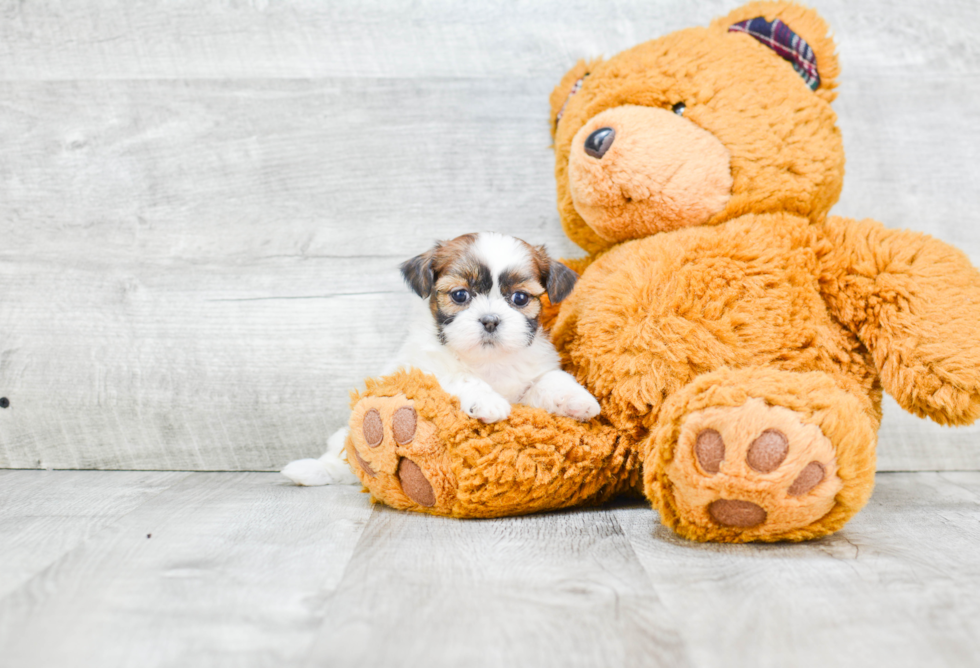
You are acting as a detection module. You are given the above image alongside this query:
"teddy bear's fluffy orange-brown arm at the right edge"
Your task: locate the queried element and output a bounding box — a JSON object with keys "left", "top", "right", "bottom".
{"left": 819, "top": 217, "right": 980, "bottom": 425}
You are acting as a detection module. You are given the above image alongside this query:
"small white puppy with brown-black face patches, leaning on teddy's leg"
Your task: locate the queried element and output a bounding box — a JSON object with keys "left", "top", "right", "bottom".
{"left": 282, "top": 232, "right": 599, "bottom": 485}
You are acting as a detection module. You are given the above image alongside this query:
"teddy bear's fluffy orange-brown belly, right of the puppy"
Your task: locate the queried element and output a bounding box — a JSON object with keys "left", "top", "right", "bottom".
{"left": 553, "top": 215, "right": 877, "bottom": 426}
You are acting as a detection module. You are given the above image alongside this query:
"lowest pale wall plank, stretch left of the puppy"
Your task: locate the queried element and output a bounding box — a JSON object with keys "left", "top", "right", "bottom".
{"left": 0, "top": 258, "right": 408, "bottom": 470}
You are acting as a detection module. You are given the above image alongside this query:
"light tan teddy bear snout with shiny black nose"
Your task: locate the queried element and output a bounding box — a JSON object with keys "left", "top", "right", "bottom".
{"left": 568, "top": 105, "right": 732, "bottom": 241}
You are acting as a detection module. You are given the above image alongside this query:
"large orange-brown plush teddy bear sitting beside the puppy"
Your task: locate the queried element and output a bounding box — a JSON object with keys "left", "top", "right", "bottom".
{"left": 338, "top": 2, "right": 980, "bottom": 542}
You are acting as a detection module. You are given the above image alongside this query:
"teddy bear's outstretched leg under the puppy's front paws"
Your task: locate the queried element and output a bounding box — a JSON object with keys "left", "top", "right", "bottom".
{"left": 346, "top": 370, "right": 639, "bottom": 517}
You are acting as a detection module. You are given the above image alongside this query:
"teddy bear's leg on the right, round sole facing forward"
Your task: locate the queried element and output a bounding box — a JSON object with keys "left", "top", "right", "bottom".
{"left": 644, "top": 368, "right": 878, "bottom": 542}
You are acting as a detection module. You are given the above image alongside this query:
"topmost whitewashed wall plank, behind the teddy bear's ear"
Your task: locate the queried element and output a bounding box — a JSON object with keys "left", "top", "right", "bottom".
{"left": 0, "top": 0, "right": 980, "bottom": 81}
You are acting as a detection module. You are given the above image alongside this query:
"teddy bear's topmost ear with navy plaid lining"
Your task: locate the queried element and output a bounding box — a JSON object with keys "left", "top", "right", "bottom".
{"left": 711, "top": 2, "right": 840, "bottom": 102}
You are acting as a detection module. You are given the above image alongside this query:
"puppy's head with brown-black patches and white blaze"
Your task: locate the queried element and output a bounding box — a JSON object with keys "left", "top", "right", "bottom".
{"left": 402, "top": 233, "right": 578, "bottom": 355}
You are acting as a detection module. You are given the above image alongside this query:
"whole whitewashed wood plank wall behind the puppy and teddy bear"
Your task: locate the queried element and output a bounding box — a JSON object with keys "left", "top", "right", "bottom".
{"left": 0, "top": 0, "right": 980, "bottom": 470}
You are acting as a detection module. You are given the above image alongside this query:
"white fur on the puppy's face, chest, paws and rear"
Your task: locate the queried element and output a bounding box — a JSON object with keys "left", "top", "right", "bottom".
{"left": 282, "top": 233, "right": 599, "bottom": 485}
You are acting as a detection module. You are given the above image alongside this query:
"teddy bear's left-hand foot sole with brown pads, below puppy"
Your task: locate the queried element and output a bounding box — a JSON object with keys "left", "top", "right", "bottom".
{"left": 346, "top": 394, "right": 456, "bottom": 514}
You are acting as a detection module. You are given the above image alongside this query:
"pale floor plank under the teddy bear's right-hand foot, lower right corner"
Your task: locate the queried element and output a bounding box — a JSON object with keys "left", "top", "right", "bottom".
{"left": 616, "top": 473, "right": 980, "bottom": 667}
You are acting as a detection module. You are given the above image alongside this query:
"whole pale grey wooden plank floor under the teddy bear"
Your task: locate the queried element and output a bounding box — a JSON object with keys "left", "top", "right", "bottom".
{"left": 0, "top": 471, "right": 980, "bottom": 668}
